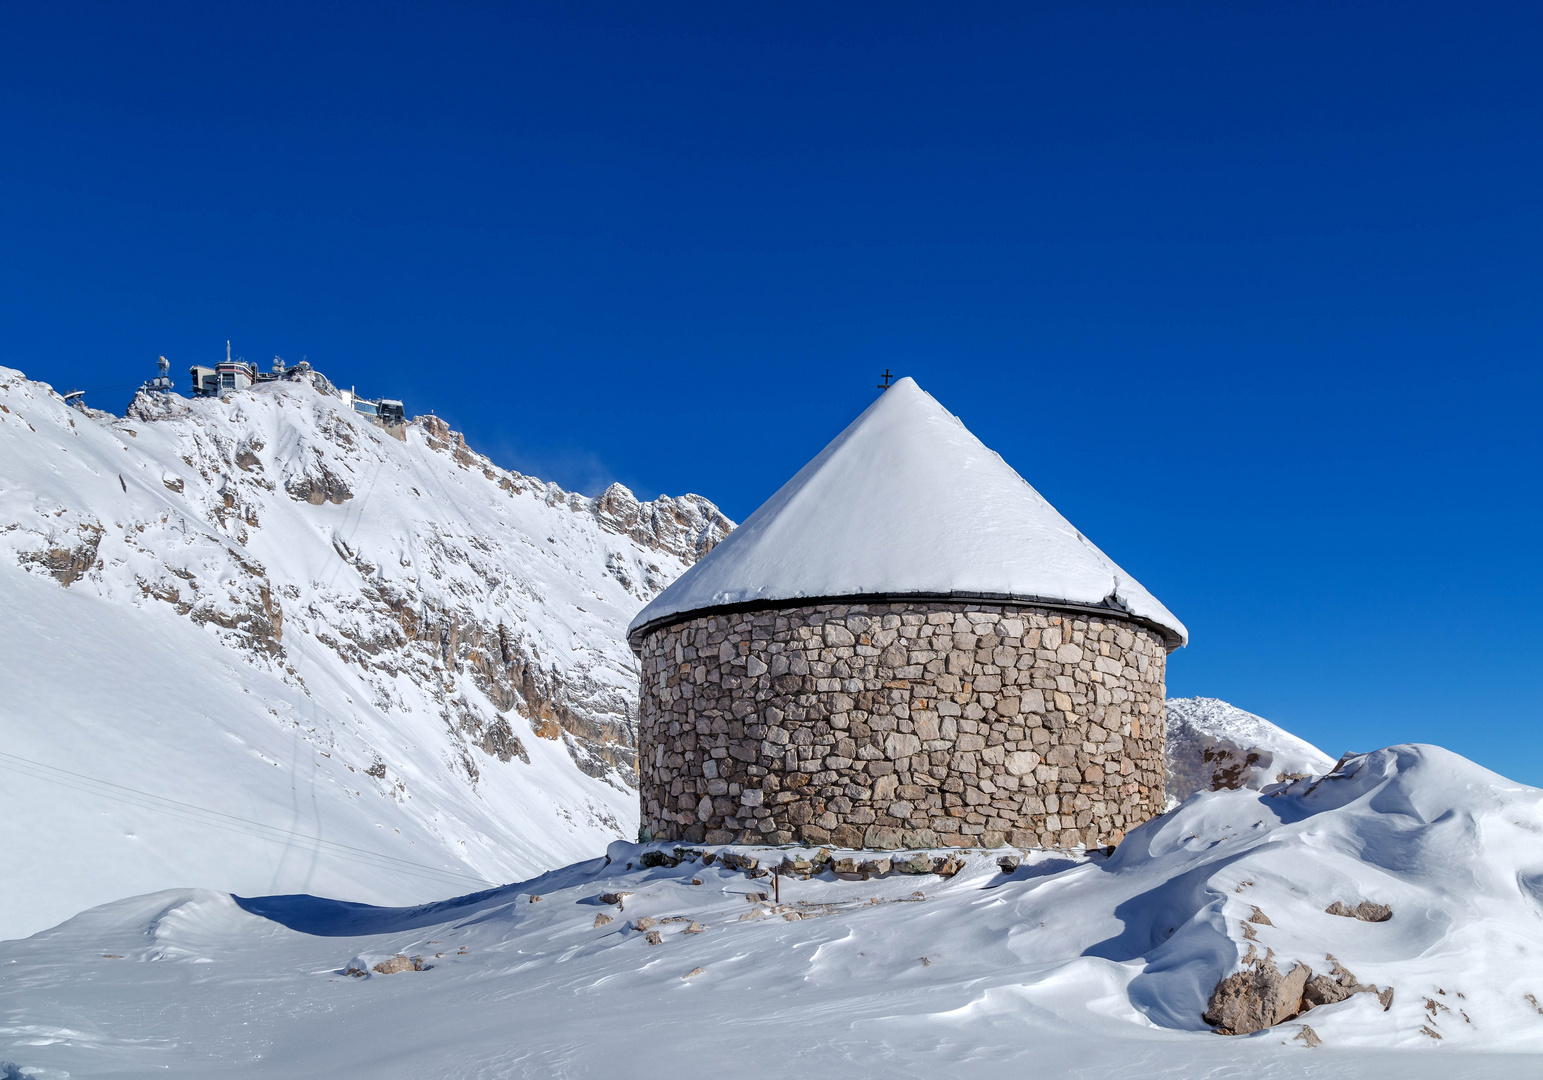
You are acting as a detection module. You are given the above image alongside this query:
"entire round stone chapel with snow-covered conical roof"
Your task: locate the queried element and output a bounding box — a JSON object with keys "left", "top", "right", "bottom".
{"left": 628, "top": 378, "right": 1188, "bottom": 849}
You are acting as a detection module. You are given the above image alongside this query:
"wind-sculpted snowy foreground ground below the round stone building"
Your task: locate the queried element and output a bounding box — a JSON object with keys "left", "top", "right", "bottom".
{"left": 0, "top": 745, "right": 1543, "bottom": 1080}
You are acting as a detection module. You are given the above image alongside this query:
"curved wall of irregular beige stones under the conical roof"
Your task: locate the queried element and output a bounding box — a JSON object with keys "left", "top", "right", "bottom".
{"left": 639, "top": 603, "right": 1167, "bottom": 849}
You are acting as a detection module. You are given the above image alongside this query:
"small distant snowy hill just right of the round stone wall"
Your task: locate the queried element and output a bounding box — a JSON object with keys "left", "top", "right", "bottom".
{"left": 1167, "top": 697, "right": 1335, "bottom": 807}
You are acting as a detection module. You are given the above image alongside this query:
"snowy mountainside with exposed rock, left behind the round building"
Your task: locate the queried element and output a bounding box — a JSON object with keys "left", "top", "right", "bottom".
{"left": 0, "top": 369, "right": 730, "bottom": 938}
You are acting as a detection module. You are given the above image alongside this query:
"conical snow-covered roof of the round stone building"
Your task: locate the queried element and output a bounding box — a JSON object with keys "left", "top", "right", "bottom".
{"left": 628, "top": 378, "right": 1188, "bottom": 648}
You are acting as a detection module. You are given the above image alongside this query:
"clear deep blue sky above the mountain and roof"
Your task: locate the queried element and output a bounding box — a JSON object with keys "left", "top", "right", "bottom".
{"left": 0, "top": 2, "right": 1543, "bottom": 784}
